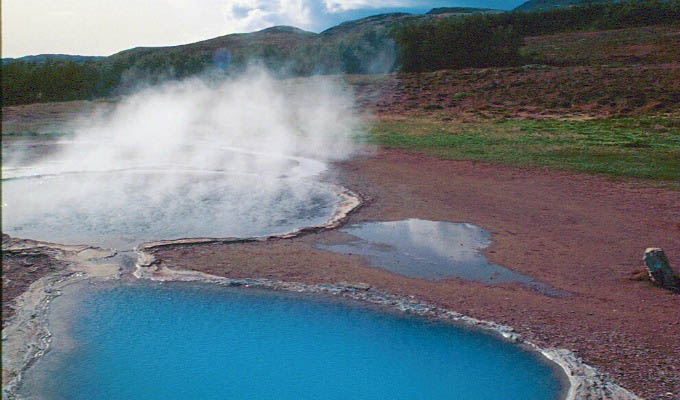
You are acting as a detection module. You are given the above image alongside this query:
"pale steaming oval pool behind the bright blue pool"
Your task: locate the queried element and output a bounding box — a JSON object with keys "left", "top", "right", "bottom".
{"left": 2, "top": 170, "right": 338, "bottom": 249}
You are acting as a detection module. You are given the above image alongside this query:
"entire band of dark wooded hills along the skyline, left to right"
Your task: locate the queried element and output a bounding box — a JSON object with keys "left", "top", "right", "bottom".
{"left": 2, "top": 0, "right": 680, "bottom": 105}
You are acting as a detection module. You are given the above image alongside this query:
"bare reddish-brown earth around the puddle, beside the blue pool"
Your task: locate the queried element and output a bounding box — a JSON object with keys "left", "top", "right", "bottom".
{"left": 156, "top": 150, "right": 680, "bottom": 398}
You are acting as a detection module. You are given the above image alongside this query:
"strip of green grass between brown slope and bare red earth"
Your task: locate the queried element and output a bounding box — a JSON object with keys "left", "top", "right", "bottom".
{"left": 370, "top": 116, "right": 680, "bottom": 184}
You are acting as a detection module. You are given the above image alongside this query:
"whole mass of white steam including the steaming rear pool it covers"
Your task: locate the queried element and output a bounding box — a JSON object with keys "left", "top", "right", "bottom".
{"left": 3, "top": 69, "right": 370, "bottom": 248}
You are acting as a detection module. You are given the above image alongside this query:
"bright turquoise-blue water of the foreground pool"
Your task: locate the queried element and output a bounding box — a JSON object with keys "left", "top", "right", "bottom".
{"left": 22, "top": 283, "right": 561, "bottom": 400}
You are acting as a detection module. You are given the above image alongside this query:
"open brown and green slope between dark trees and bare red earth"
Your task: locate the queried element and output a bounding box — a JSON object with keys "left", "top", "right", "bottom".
{"left": 347, "top": 21, "right": 680, "bottom": 183}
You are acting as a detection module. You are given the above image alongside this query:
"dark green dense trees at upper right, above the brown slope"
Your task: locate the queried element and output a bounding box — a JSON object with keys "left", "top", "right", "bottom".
{"left": 394, "top": 1, "right": 680, "bottom": 72}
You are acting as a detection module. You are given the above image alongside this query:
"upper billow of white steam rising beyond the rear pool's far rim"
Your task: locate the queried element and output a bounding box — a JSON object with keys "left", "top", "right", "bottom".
{"left": 58, "top": 69, "right": 360, "bottom": 173}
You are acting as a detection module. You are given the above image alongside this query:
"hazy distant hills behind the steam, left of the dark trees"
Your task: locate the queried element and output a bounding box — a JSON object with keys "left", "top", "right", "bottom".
{"left": 2, "top": 14, "right": 414, "bottom": 105}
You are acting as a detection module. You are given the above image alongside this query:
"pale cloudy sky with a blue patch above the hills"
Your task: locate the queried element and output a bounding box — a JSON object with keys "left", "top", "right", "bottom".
{"left": 2, "top": 0, "right": 523, "bottom": 57}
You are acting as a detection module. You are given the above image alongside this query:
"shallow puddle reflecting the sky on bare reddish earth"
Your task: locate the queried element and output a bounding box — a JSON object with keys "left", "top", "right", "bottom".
{"left": 316, "top": 219, "right": 566, "bottom": 296}
